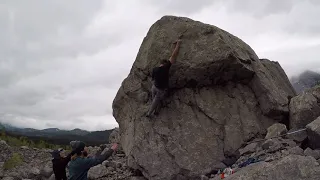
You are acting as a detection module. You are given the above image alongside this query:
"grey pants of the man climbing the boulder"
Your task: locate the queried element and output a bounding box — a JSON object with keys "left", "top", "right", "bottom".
{"left": 148, "top": 85, "right": 167, "bottom": 115}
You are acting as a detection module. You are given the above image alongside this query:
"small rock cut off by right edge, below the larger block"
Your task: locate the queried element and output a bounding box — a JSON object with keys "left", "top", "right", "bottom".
{"left": 307, "top": 117, "right": 320, "bottom": 149}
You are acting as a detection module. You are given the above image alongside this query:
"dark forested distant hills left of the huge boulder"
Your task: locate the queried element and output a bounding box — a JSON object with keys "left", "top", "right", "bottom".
{"left": 0, "top": 124, "right": 113, "bottom": 146}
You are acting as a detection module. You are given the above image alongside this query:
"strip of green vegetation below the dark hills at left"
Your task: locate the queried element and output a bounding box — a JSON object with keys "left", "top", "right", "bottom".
{"left": 0, "top": 129, "right": 70, "bottom": 149}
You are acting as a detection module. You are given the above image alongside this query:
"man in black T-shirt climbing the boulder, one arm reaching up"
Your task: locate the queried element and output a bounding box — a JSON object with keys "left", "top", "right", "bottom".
{"left": 146, "top": 39, "right": 181, "bottom": 117}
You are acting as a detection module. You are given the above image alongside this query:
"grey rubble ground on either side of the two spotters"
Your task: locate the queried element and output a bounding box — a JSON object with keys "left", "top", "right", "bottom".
{"left": 0, "top": 141, "right": 144, "bottom": 180}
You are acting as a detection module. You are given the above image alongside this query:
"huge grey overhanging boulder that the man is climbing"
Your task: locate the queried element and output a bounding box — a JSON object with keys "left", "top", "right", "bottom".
{"left": 113, "top": 16, "right": 295, "bottom": 180}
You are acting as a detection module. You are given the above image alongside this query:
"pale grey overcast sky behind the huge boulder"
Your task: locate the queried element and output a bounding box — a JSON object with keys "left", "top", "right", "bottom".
{"left": 0, "top": 0, "right": 320, "bottom": 130}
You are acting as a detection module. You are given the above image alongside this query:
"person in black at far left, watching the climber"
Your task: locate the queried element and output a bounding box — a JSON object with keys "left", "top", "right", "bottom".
{"left": 51, "top": 149, "right": 74, "bottom": 180}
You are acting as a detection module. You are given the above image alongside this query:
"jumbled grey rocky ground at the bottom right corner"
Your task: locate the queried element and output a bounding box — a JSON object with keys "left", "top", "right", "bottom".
{"left": 205, "top": 118, "right": 320, "bottom": 180}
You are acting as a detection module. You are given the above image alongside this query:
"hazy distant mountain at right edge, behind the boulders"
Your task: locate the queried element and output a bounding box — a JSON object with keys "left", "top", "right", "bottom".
{"left": 290, "top": 70, "right": 320, "bottom": 94}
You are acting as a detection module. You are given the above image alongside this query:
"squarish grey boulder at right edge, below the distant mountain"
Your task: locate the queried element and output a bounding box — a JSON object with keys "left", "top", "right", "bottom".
{"left": 289, "top": 86, "right": 320, "bottom": 129}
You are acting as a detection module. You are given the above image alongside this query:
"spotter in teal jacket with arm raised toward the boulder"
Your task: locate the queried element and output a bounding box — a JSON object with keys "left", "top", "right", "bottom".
{"left": 68, "top": 141, "right": 118, "bottom": 180}
